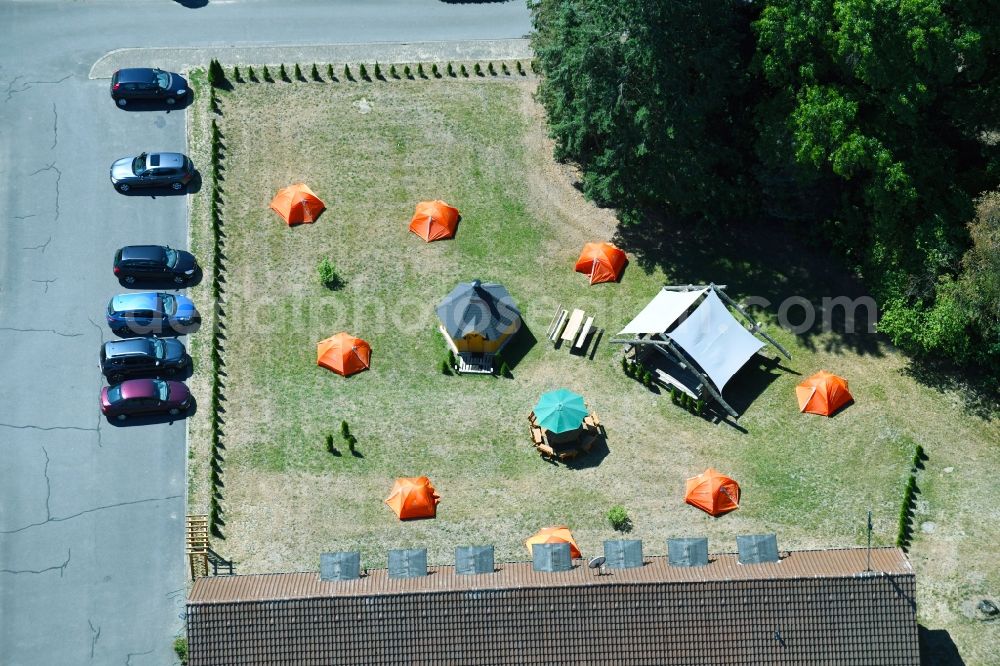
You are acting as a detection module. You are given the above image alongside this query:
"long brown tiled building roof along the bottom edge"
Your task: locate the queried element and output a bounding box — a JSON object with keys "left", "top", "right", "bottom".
{"left": 187, "top": 549, "right": 919, "bottom": 666}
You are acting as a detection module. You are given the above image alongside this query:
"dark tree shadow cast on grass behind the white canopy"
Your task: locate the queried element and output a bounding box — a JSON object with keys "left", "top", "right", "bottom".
{"left": 614, "top": 214, "right": 886, "bottom": 356}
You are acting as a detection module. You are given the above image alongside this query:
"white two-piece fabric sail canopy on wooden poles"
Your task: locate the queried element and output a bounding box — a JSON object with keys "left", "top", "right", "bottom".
{"left": 612, "top": 284, "right": 791, "bottom": 417}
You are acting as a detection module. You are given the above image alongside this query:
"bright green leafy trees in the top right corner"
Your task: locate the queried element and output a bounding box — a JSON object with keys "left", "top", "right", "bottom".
{"left": 754, "top": 0, "right": 1000, "bottom": 368}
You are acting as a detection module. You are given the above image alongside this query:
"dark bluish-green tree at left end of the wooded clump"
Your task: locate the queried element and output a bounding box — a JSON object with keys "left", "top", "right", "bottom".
{"left": 532, "top": 0, "right": 750, "bottom": 222}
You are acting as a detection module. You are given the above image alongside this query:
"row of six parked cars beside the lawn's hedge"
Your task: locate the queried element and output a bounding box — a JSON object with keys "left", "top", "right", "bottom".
{"left": 100, "top": 68, "right": 201, "bottom": 421}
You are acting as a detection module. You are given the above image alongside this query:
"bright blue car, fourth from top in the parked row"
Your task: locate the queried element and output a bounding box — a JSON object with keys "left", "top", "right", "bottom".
{"left": 108, "top": 291, "right": 201, "bottom": 337}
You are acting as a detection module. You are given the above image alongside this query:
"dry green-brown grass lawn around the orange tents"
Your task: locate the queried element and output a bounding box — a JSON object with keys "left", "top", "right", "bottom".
{"left": 189, "top": 66, "right": 1000, "bottom": 663}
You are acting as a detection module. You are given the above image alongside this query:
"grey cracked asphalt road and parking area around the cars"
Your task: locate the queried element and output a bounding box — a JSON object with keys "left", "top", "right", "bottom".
{"left": 0, "top": 0, "right": 529, "bottom": 666}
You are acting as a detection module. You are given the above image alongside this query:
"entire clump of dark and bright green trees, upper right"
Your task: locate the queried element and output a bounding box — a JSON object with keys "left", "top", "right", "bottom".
{"left": 532, "top": 0, "right": 1000, "bottom": 376}
